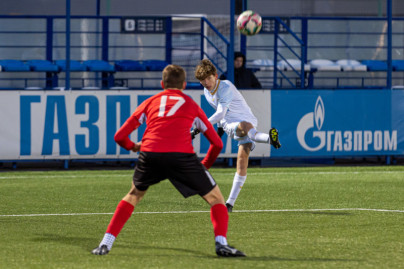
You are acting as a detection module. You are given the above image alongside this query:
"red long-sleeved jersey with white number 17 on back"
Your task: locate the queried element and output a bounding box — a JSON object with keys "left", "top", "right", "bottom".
{"left": 115, "top": 89, "right": 223, "bottom": 168}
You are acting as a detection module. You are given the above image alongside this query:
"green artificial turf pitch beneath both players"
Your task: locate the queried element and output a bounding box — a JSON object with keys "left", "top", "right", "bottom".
{"left": 0, "top": 166, "right": 404, "bottom": 269}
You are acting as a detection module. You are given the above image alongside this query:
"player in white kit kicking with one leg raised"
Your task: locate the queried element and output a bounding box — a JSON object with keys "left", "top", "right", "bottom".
{"left": 191, "top": 59, "right": 281, "bottom": 212}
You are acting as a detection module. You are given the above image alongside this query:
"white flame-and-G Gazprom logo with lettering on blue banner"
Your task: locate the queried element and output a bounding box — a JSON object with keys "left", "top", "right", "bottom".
{"left": 296, "top": 96, "right": 397, "bottom": 152}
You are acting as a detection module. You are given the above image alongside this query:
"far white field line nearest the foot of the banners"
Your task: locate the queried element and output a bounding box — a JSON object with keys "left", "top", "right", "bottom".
{"left": 0, "top": 170, "right": 404, "bottom": 179}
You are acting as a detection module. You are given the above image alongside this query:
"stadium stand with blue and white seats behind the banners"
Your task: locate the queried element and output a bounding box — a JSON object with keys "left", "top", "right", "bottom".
{"left": 0, "top": 16, "right": 404, "bottom": 89}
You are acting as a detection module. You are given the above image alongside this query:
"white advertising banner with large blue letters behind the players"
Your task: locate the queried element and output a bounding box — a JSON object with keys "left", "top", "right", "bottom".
{"left": 0, "top": 90, "right": 271, "bottom": 160}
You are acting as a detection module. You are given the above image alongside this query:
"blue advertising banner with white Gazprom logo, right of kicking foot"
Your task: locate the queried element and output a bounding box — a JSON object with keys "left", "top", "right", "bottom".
{"left": 271, "top": 90, "right": 404, "bottom": 157}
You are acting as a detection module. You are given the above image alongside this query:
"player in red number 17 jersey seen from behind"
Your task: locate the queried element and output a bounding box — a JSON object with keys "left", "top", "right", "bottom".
{"left": 92, "top": 65, "right": 245, "bottom": 257}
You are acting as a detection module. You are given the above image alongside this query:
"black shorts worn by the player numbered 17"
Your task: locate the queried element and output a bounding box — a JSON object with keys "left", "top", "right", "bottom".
{"left": 133, "top": 152, "right": 216, "bottom": 198}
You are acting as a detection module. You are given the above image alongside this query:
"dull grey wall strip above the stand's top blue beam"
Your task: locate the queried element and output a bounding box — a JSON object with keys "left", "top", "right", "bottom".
{"left": 0, "top": 0, "right": 404, "bottom": 16}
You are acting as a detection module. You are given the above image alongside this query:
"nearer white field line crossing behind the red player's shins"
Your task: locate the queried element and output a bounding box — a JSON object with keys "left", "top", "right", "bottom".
{"left": 0, "top": 208, "right": 404, "bottom": 218}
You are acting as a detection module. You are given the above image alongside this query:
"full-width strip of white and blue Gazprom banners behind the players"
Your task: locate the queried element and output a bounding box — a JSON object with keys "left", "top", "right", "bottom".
{"left": 0, "top": 89, "right": 404, "bottom": 160}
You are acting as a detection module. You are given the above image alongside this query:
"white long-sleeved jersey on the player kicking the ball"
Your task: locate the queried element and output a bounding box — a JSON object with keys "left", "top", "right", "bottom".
{"left": 204, "top": 80, "right": 258, "bottom": 127}
